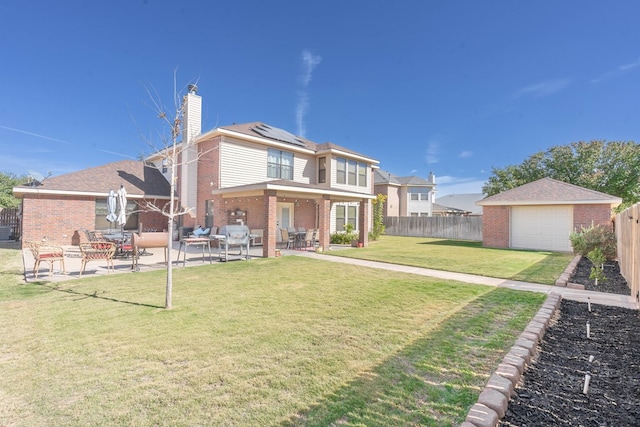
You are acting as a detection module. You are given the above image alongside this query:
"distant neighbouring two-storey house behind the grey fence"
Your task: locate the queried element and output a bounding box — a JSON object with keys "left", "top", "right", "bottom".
{"left": 374, "top": 169, "right": 436, "bottom": 218}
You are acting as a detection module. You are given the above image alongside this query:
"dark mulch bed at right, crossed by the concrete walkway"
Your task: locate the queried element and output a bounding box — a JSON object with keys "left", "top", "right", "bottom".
{"left": 499, "top": 259, "right": 640, "bottom": 427}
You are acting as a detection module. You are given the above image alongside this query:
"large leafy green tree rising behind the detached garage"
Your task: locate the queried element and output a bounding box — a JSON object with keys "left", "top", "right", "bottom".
{"left": 482, "top": 141, "right": 640, "bottom": 209}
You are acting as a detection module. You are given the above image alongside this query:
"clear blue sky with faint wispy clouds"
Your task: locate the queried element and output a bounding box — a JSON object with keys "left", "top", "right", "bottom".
{"left": 0, "top": 0, "right": 640, "bottom": 197}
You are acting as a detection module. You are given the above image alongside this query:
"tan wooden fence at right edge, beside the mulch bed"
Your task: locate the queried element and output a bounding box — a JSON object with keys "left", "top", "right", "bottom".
{"left": 616, "top": 203, "right": 640, "bottom": 303}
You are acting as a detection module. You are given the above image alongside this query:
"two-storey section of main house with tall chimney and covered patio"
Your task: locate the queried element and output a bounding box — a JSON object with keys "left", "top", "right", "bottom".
{"left": 147, "top": 86, "right": 379, "bottom": 257}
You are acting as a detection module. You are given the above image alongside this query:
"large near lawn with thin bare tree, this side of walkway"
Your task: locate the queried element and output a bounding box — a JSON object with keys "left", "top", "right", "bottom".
{"left": 0, "top": 242, "right": 544, "bottom": 426}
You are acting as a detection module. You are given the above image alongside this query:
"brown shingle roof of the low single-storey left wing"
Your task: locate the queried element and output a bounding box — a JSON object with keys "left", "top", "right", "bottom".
{"left": 14, "top": 160, "right": 171, "bottom": 198}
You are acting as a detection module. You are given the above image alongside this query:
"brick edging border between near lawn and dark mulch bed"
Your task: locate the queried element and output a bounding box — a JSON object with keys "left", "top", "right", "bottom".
{"left": 460, "top": 294, "right": 560, "bottom": 427}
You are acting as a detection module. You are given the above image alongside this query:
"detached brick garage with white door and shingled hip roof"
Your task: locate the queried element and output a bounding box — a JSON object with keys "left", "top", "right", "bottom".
{"left": 477, "top": 178, "right": 622, "bottom": 252}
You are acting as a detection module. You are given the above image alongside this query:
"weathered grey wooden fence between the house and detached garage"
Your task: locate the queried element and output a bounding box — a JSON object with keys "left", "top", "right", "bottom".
{"left": 384, "top": 216, "right": 482, "bottom": 241}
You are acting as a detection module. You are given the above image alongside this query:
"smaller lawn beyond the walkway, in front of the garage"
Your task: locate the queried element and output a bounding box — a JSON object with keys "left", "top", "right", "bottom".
{"left": 327, "top": 236, "right": 573, "bottom": 285}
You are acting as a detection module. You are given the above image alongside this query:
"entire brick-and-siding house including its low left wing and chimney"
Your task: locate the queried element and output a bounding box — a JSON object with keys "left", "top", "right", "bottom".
{"left": 14, "top": 86, "right": 378, "bottom": 257}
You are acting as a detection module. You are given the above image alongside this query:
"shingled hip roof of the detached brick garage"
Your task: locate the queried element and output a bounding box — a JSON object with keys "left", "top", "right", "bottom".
{"left": 476, "top": 178, "right": 622, "bottom": 206}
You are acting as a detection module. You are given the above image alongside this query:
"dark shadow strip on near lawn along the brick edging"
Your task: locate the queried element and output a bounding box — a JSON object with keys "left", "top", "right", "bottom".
{"left": 279, "top": 289, "right": 507, "bottom": 427}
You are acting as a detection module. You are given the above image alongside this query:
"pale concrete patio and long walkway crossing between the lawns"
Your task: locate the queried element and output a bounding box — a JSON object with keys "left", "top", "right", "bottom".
{"left": 22, "top": 242, "right": 638, "bottom": 309}
